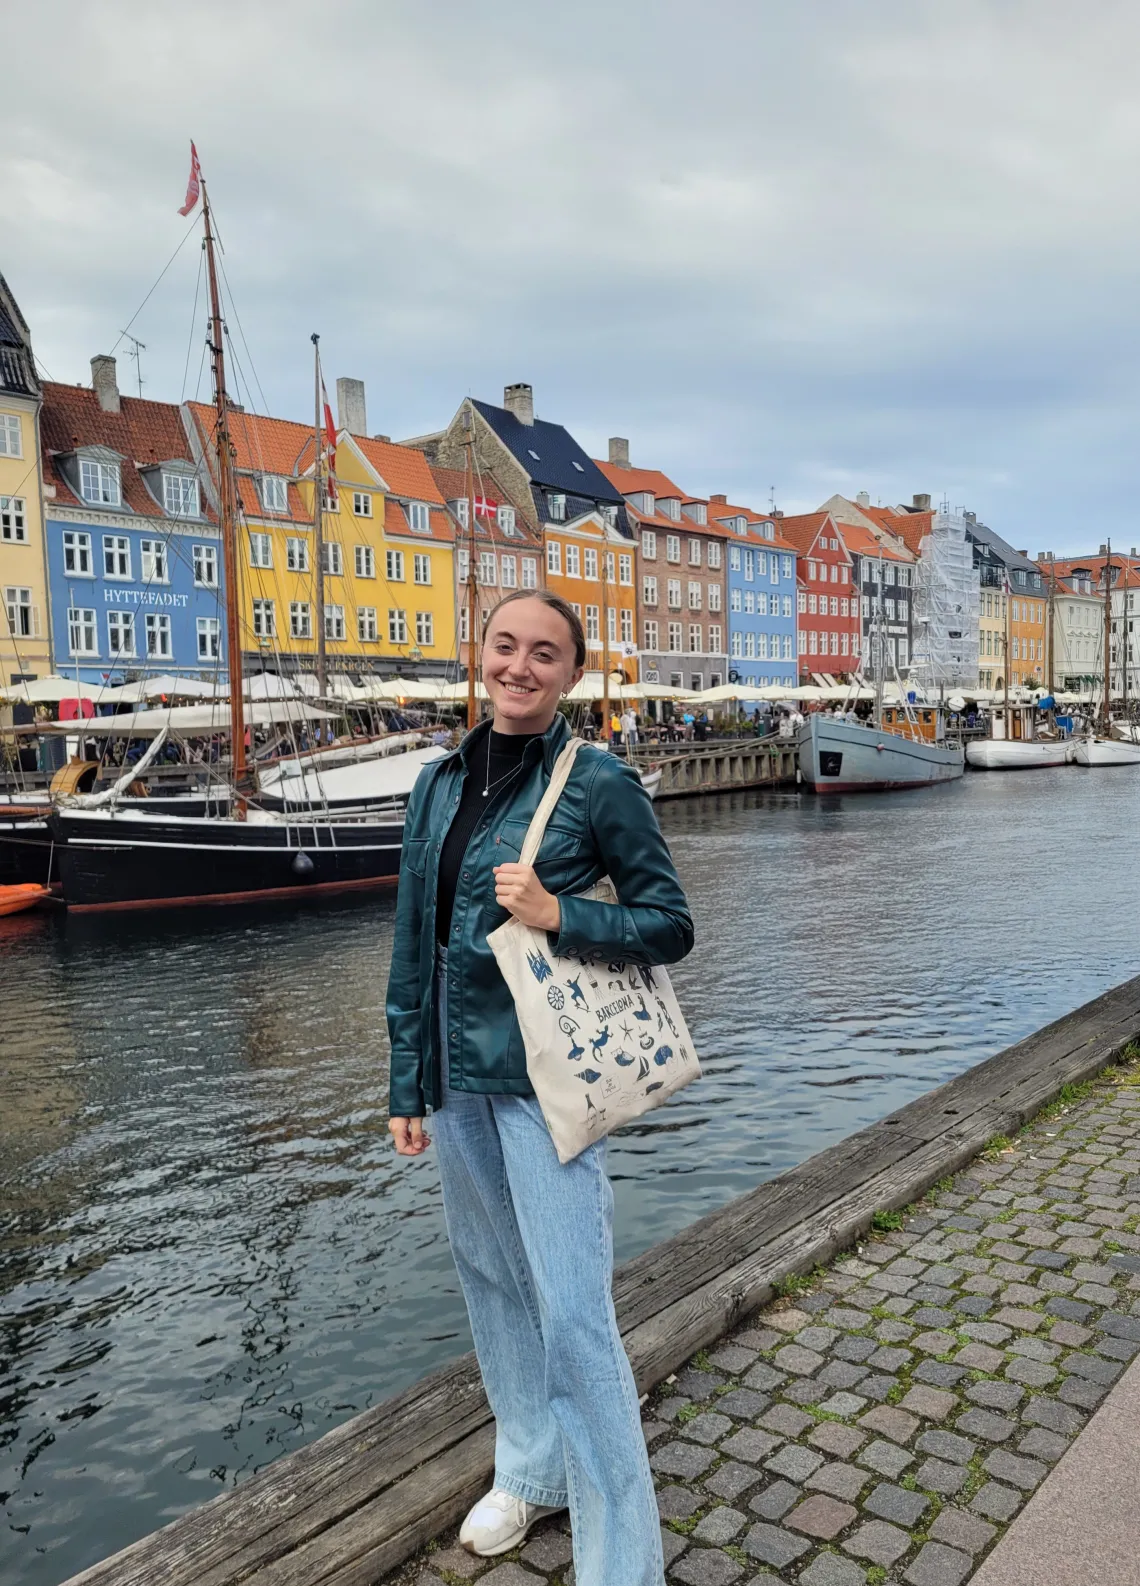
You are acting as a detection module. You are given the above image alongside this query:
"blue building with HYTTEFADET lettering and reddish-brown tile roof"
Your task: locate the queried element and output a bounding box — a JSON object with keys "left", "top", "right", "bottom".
{"left": 41, "top": 358, "right": 225, "bottom": 685}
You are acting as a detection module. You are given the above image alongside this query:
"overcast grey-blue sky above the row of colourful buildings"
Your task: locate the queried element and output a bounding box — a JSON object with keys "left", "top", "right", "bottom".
{"left": 0, "top": 0, "right": 1140, "bottom": 554}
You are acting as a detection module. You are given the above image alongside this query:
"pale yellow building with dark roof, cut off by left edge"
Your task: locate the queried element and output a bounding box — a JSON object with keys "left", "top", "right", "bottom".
{"left": 0, "top": 276, "right": 52, "bottom": 685}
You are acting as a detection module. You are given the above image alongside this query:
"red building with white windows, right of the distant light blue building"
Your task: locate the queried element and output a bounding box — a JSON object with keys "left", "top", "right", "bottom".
{"left": 777, "top": 512, "right": 861, "bottom": 682}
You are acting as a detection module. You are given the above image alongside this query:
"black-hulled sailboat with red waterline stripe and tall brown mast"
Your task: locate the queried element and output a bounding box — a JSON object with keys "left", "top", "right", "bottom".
{"left": 49, "top": 165, "right": 415, "bottom": 910}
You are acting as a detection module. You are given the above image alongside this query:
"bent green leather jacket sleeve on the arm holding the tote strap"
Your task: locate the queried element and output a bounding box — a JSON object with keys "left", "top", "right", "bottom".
{"left": 553, "top": 755, "right": 693, "bottom": 964}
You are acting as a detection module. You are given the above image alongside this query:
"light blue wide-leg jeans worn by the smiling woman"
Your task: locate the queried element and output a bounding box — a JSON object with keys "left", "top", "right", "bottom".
{"left": 431, "top": 955, "right": 664, "bottom": 1586}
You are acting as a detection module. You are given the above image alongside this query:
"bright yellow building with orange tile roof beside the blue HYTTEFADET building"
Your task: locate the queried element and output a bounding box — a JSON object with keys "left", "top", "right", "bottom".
{"left": 186, "top": 403, "right": 457, "bottom": 676}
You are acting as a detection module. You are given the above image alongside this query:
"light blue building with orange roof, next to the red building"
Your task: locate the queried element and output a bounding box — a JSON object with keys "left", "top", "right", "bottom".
{"left": 709, "top": 496, "right": 799, "bottom": 688}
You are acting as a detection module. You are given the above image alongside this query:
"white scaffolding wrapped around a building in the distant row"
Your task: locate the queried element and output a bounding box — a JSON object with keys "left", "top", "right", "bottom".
{"left": 910, "top": 512, "right": 980, "bottom": 693}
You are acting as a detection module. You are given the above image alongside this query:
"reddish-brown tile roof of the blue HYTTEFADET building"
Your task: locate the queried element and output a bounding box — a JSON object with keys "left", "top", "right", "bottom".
{"left": 40, "top": 381, "right": 216, "bottom": 522}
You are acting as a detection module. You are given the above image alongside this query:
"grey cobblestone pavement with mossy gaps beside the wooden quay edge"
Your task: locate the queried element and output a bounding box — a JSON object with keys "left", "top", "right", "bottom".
{"left": 401, "top": 1064, "right": 1140, "bottom": 1586}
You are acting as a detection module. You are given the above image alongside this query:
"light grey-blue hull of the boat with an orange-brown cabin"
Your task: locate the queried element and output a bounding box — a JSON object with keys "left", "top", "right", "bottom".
{"left": 796, "top": 712, "right": 966, "bottom": 793}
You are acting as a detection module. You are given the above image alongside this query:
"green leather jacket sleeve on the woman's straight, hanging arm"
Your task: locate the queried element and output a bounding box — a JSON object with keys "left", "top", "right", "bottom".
{"left": 385, "top": 776, "right": 431, "bottom": 1118}
